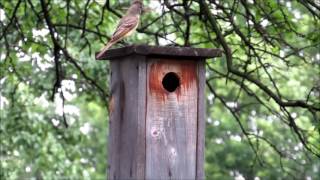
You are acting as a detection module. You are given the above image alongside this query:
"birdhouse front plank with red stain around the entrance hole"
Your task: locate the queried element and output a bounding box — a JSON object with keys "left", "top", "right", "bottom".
{"left": 146, "top": 59, "right": 198, "bottom": 179}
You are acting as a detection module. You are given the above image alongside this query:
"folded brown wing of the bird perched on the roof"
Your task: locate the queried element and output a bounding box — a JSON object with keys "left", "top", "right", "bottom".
{"left": 110, "top": 16, "right": 139, "bottom": 42}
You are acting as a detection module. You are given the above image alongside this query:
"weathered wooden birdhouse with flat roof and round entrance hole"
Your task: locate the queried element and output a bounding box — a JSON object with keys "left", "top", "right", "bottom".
{"left": 96, "top": 45, "right": 221, "bottom": 179}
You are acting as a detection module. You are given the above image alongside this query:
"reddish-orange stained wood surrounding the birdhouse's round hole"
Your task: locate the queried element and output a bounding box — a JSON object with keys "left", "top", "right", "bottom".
{"left": 149, "top": 59, "right": 197, "bottom": 102}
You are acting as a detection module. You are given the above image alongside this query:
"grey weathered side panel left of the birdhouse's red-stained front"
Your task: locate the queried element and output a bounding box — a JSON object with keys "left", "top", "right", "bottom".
{"left": 109, "top": 56, "right": 146, "bottom": 179}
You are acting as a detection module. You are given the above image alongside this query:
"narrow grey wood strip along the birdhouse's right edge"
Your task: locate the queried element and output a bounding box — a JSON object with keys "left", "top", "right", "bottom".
{"left": 196, "top": 60, "right": 206, "bottom": 179}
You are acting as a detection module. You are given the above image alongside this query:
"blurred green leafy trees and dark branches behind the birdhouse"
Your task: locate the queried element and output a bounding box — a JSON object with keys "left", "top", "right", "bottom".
{"left": 0, "top": 0, "right": 320, "bottom": 180}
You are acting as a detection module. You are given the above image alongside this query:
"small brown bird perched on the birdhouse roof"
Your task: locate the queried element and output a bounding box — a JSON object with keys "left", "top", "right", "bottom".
{"left": 96, "top": 0, "right": 143, "bottom": 59}
